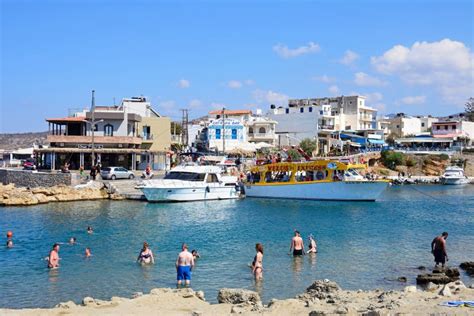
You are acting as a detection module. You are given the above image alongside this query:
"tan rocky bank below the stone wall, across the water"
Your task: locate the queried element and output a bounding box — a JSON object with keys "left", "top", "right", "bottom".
{"left": 0, "top": 182, "right": 113, "bottom": 206}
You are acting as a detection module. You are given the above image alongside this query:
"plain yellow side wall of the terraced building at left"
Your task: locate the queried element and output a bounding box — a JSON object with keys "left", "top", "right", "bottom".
{"left": 138, "top": 117, "right": 171, "bottom": 151}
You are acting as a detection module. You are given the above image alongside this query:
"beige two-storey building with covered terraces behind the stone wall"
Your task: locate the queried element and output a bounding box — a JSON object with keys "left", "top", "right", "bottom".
{"left": 35, "top": 97, "right": 171, "bottom": 170}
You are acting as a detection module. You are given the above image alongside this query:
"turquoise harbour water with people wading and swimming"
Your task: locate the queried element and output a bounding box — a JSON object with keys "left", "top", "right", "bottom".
{"left": 0, "top": 185, "right": 474, "bottom": 308}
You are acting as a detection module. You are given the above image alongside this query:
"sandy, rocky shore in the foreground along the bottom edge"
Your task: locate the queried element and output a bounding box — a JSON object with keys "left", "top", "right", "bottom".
{"left": 0, "top": 280, "right": 474, "bottom": 316}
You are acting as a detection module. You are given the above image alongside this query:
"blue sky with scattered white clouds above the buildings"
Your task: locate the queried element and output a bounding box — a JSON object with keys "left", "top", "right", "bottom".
{"left": 0, "top": 0, "right": 474, "bottom": 133}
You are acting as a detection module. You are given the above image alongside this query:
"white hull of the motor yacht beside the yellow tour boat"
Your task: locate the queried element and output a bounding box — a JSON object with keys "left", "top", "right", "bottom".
{"left": 141, "top": 186, "right": 240, "bottom": 202}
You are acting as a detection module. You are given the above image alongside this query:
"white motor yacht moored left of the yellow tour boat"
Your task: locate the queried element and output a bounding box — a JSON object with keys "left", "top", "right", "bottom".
{"left": 137, "top": 165, "right": 240, "bottom": 202}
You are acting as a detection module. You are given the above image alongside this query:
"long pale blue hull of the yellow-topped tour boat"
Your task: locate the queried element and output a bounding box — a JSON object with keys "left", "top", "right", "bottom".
{"left": 245, "top": 181, "right": 389, "bottom": 201}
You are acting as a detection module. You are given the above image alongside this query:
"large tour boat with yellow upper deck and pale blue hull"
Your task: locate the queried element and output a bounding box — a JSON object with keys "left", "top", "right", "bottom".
{"left": 245, "top": 160, "right": 390, "bottom": 201}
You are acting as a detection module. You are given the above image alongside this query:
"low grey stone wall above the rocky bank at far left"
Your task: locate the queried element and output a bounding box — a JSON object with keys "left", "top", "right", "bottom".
{"left": 0, "top": 169, "right": 71, "bottom": 188}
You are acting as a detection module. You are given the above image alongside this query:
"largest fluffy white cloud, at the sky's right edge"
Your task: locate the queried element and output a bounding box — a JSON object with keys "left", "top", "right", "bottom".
{"left": 371, "top": 39, "right": 474, "bottom": 106}
